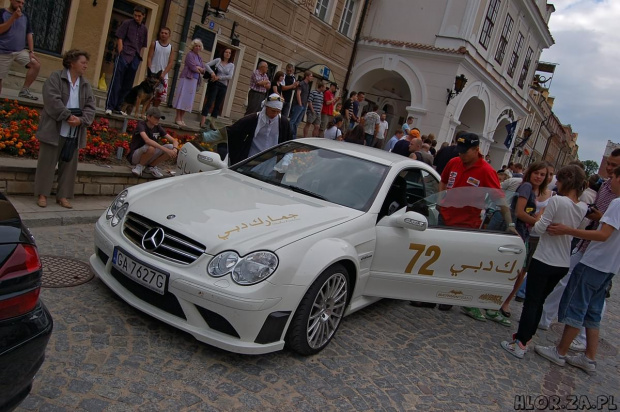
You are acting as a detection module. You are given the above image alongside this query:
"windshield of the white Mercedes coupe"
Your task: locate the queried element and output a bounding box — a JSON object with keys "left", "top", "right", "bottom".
{"left": 231, "top": 142, "right": 389, "bottom": 211}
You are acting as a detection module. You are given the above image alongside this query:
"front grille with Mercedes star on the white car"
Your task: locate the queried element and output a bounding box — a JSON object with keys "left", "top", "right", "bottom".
{"left": 123, "top": 212, "right": 206, "bottom": 265}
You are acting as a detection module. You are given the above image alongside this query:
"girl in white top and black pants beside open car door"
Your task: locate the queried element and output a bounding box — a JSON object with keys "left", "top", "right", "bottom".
{"left": 501, "top": 165, "right": 588, "bottom": 358}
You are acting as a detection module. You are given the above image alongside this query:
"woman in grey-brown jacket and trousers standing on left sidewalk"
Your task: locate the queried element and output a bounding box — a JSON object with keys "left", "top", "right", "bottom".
{"left": 34, "top": 49, "right": 95, "bottom": 209}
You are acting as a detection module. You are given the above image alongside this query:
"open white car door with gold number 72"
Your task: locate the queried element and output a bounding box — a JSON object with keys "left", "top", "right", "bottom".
{"left": 364, "top": 169, "right": 526, "bottom": 308}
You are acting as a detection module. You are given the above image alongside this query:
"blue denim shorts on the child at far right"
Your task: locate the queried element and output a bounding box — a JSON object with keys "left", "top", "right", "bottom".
{"left": 558, "top": 263, "right": 614, "bottom": 329}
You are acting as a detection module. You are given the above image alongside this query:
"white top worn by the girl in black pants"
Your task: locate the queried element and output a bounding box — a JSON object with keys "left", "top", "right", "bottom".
{"left": 533, "top": 196, "right": 588, "bottom": 268}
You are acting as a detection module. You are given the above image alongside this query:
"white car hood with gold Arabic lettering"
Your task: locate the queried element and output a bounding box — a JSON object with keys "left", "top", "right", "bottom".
{"left": 128, "top": 170, "right": 363, "bottom": 255}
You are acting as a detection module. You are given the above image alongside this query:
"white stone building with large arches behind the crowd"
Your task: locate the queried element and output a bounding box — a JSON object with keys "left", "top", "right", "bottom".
{"left": 349, "top": 0, "right": 554, "bottom": 168}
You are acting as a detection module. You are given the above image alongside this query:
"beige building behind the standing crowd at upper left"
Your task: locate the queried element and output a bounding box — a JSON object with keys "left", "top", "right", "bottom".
{"left": 4, "top": 0, "right": 363, "bottom": 119}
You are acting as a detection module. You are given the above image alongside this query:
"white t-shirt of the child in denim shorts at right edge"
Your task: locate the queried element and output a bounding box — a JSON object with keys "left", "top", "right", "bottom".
{"left": 581, "top": 198, "right": 620, "bottom": 274}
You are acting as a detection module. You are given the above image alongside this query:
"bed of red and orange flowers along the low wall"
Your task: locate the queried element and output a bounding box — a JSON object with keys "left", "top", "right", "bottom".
{"left": 0, "top": 99, "right": 194, "bottom": 163}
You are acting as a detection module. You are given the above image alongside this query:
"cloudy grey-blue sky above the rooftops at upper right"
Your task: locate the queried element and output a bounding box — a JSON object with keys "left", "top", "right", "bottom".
{"left": 540, "top": 0, "right": 620, "bottom": 164}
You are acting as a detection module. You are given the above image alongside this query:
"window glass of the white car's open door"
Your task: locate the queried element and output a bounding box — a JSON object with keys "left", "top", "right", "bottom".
{"left": 408, "top": 187, "right": 516, "bottom": 232}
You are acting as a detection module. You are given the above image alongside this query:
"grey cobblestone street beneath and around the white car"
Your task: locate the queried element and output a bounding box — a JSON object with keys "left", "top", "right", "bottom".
{"left": 18, "top": 224, "right": 620, "bottom": 411}
